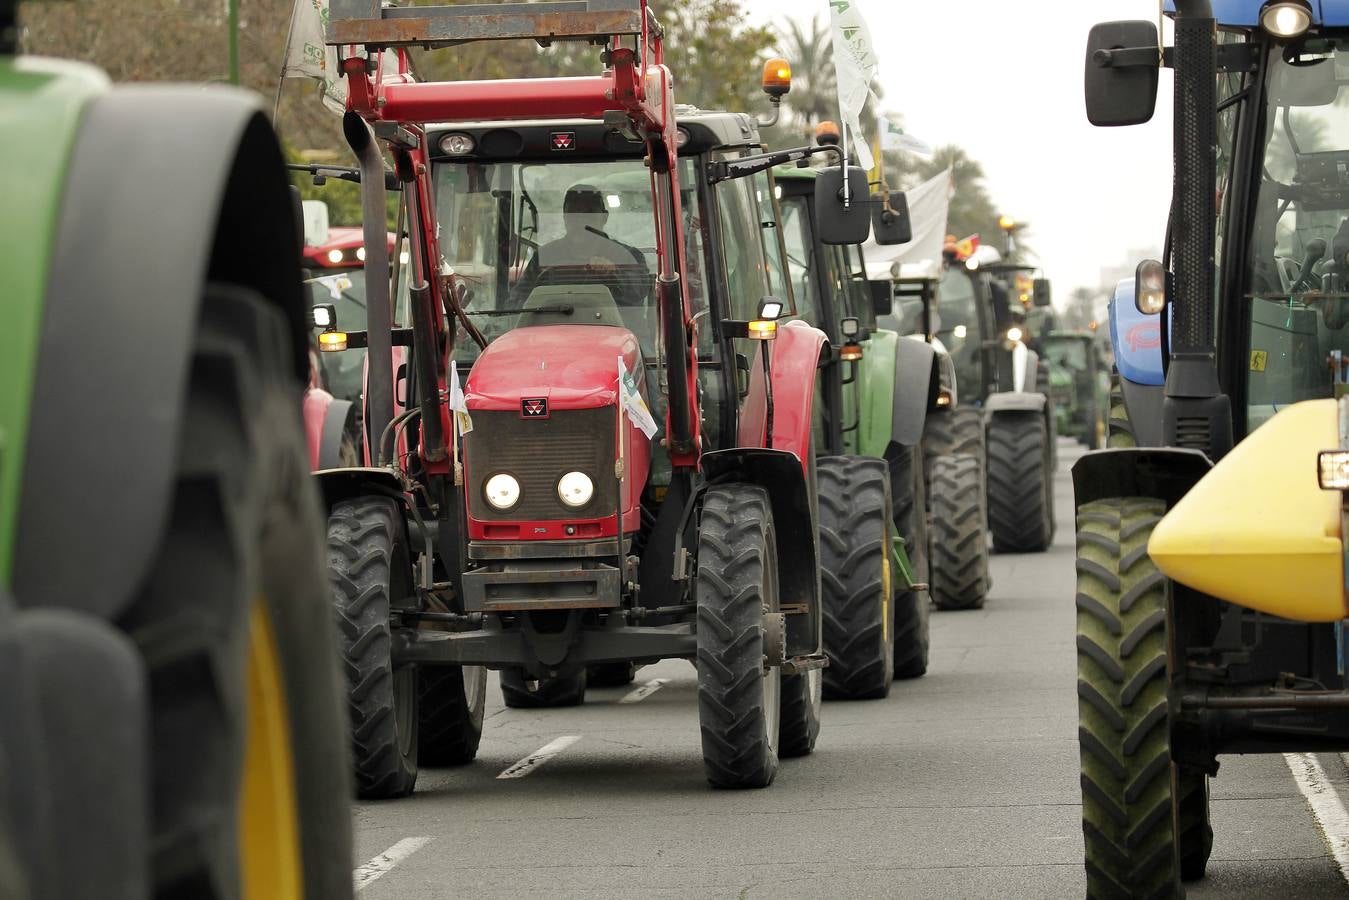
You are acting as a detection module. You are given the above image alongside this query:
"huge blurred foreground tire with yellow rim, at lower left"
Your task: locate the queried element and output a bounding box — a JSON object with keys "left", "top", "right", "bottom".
{"left": 134, "top": 285, "right": 352, "bottom": 900}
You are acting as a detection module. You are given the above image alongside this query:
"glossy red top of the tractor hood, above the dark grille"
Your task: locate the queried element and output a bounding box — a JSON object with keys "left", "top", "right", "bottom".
{"left": 464, "top": 325, "right": 639, "bottom": 410}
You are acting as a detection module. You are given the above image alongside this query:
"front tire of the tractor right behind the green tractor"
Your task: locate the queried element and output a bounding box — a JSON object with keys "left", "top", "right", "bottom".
{"left": 928, "top": 455, "right": 989, "bottom": 610}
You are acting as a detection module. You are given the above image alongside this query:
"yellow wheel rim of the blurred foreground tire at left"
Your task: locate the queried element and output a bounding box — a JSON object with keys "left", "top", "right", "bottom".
{"left": 239, "top": 598, "right": 304, "bottom": 900}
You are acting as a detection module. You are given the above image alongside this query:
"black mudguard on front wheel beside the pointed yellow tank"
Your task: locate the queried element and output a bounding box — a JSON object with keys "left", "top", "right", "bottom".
{"left": 1072, "top": 447, "right": 1213, "bottom": 509}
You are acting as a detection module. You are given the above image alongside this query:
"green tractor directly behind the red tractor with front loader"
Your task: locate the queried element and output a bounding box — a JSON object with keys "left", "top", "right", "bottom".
{"left": 774, "top": 166, "right": 942, "bottom": 698}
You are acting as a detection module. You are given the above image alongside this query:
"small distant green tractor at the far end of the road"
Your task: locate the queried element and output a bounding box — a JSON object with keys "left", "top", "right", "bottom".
{"left": 1040, "top": 331, "right": 1110, "bottom": 449}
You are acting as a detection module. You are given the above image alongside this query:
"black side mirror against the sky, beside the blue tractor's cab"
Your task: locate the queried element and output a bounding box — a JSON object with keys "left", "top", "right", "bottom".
{"left": 1086, "top": 20, "right": 1161, "bottom": 128}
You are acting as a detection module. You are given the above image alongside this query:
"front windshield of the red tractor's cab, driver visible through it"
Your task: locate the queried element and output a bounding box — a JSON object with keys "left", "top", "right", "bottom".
{"left": 436, "top": 159, "right": 679, "bottom": 362}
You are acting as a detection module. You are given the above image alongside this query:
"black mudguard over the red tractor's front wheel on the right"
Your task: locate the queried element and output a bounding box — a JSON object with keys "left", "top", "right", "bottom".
{"left": 703, "top": 447, "right": 823, "bottom": 656}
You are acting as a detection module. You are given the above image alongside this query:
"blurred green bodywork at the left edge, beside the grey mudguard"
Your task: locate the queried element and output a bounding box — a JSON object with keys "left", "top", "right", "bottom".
{"left": 0, "top": 57, "right": 108, "bottom": 588}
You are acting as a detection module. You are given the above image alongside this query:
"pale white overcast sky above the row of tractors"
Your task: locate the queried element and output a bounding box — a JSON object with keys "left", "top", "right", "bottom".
{"left": 743, "top": 0, "right": 1172, "bottom": 297}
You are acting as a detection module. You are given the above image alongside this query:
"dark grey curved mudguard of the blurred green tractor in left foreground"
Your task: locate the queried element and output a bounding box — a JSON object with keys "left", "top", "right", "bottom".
{"left": 13, "top": 86, "right": 309, "bottom": 618}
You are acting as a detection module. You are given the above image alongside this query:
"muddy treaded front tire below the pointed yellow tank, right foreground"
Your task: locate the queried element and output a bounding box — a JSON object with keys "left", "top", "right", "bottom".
{"left": 1077, "top": 498, "right": 1180, "bottom": 897}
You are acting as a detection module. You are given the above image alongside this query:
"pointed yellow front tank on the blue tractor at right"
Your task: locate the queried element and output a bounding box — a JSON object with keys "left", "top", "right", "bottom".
{"left": 1148, "top": 399, "right": 1346, "bottom": 622}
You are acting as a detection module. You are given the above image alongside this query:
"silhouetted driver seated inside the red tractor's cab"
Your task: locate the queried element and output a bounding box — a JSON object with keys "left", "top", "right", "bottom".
{"left": 511, "top": 184, "right": 652, "bottom": 309}
